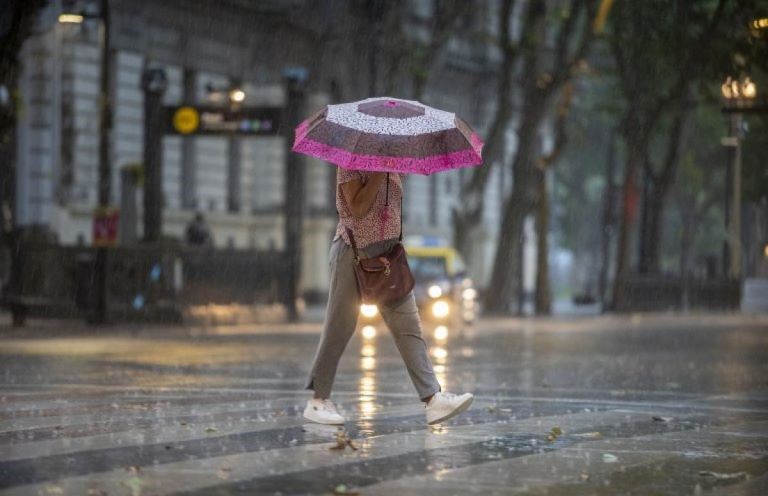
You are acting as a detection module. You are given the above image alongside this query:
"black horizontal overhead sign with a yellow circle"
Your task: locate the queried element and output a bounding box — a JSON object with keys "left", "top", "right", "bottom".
{"left": 165, "top": 105, "right": 282, "bottom": 136}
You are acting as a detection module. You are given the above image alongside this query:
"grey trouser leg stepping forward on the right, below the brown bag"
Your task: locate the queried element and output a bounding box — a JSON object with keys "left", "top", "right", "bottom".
{"left": 381, "top": 292, "right": 441, "bottom": 402}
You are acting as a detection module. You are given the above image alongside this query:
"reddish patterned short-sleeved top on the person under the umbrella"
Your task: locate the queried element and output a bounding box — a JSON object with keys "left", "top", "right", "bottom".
{"left": 333, "top": 167, "right": 403, "bottom": 250}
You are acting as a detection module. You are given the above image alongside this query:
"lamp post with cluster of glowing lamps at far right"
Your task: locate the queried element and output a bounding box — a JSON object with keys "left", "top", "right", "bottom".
{"left": 721, "top": 76, "right": 757, "bottom": 279}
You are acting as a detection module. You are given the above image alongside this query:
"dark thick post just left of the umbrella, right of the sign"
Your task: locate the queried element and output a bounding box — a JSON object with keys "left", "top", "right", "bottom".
{"left": 282, "top": 70, "right": 306, "bottom": 322}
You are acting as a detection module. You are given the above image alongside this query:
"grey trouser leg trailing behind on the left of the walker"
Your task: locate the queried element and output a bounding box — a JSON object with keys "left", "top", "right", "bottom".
{"left": 306, "top": 239, "right": 360, "bottom": 399}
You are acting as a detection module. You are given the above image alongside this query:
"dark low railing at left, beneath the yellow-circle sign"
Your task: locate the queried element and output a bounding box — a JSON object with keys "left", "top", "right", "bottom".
{"left": 4, "top": 244, "right": 286, "bottom": 321}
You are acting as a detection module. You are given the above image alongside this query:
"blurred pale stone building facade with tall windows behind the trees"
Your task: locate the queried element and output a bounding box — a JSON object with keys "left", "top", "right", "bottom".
{"left": 16, "top": 0, "right": 532, "bottom": 293}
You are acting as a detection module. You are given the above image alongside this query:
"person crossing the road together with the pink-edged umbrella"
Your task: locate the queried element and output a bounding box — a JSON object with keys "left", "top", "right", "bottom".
{"left": 293, "top": 97, "right": 483, "bottom": 425}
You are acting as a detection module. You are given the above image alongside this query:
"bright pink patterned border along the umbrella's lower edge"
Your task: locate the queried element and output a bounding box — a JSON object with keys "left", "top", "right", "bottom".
{"left": 293, "top": 135, "right": 483, "bottom": 175}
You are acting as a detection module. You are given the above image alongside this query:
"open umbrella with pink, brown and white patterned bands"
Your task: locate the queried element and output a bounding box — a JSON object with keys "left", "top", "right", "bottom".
{"left": 293, "top": 97, "right": 483, "bottom": 175}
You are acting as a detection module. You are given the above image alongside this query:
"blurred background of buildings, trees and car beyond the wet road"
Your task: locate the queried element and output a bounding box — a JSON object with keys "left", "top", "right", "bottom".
{"left": 0, "top": 0, "right": 768, "bottom": 325}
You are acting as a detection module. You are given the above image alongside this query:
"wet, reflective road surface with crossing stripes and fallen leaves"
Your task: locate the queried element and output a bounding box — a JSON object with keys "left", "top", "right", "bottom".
{"left": 0, "top": 316, "right": 768, "bottom": 495}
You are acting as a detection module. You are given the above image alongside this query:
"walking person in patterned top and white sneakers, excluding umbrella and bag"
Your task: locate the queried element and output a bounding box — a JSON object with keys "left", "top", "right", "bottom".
{"left": 304, "top": 167, "right": 474, "bottom": 425}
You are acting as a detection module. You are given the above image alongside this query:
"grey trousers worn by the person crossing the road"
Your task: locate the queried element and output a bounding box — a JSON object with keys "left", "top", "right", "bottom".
{"left": 306, "top": 234, "right": 440, "bottom": 399}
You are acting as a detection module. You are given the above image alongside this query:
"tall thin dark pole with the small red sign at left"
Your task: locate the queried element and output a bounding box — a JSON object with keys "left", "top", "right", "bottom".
{"left": 93, "top": 0, "right": 112, "bottom": 324}
